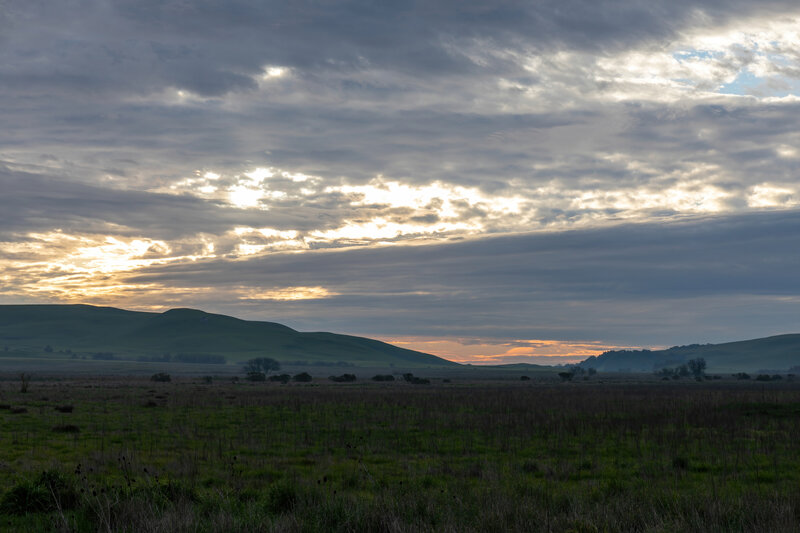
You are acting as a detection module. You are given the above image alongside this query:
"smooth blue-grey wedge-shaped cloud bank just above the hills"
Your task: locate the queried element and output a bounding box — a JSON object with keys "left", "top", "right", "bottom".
{"left": 117, "top": 212, "right": 800, "bottom": 344}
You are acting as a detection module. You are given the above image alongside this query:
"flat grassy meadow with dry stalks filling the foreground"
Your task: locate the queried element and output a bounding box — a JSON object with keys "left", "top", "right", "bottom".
{"left": 0, "top": 376, "right": 800, "bottom": 532}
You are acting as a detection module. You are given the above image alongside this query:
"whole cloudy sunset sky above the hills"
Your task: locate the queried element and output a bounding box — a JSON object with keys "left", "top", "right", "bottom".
{"left": 0, "top": 0, "right": 800, "bottom": 363}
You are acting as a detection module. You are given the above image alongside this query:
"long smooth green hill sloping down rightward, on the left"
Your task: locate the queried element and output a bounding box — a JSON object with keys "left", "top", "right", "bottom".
{"left": 0, "top": 305, "right": 457, "bottom": 367}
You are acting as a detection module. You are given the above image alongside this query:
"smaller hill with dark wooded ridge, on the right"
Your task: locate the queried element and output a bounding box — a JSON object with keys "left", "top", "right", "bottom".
{"left": 580, "top": 334, "right": 800, "bottom": 372}
